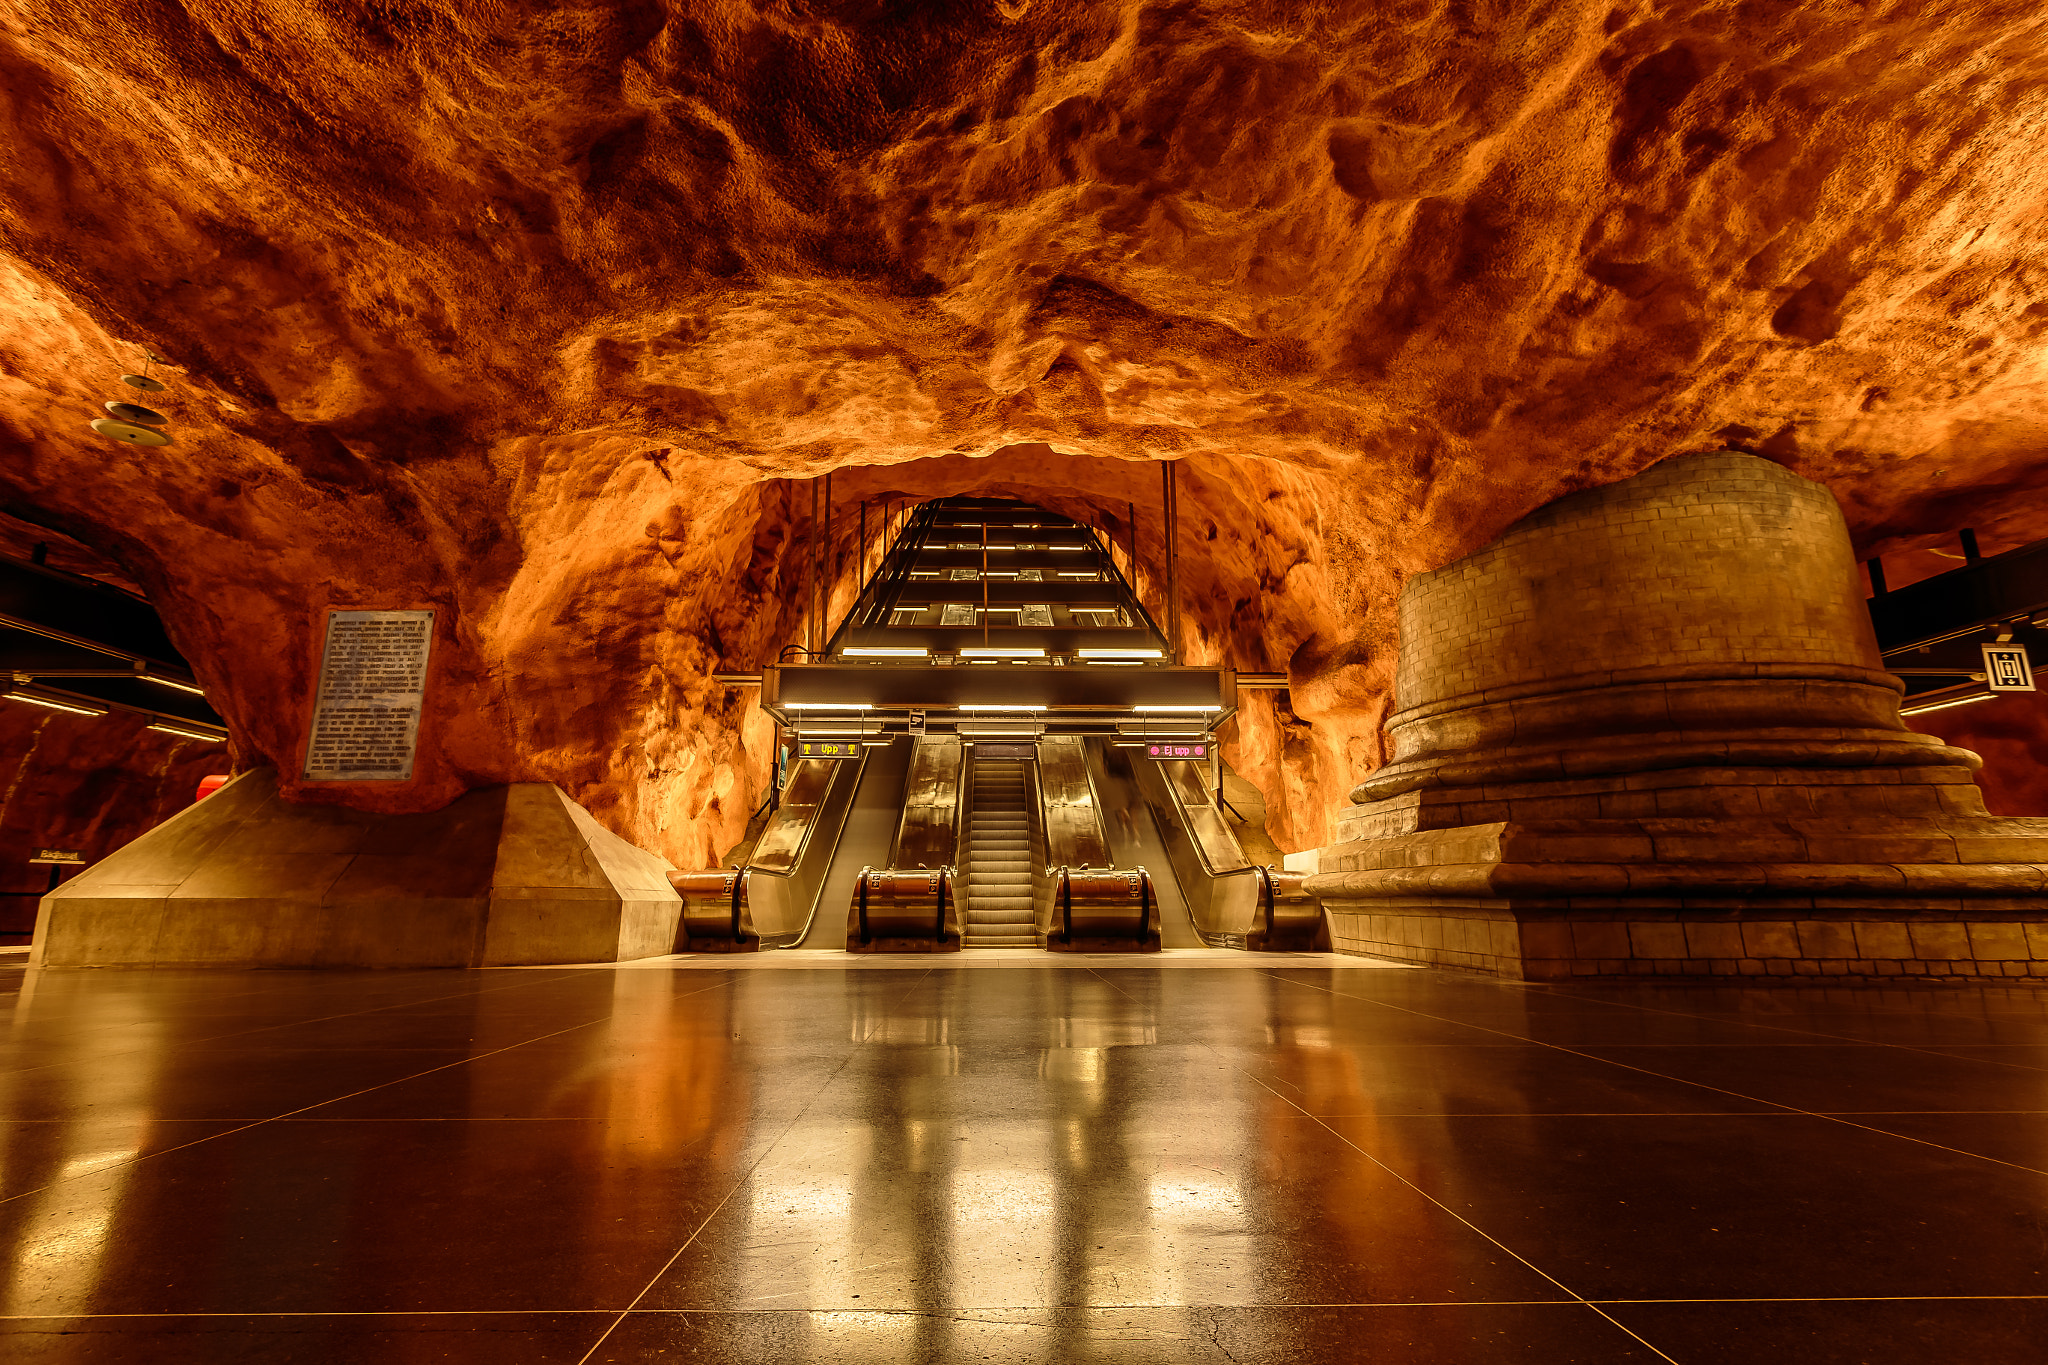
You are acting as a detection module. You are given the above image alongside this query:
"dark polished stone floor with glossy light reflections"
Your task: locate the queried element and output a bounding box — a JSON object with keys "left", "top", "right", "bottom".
{"left": 0, "top": 964, "right": 2048, "bottom": 1365}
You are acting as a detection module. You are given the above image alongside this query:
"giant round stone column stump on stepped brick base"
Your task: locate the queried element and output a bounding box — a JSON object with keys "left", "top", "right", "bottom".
{"left": 1309, "top": 450, "right": 2048, "bottom": 978}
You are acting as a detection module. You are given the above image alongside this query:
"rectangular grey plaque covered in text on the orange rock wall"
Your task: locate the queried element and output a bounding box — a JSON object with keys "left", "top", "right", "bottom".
{"left": 305, "top": 612, "right": 434, "bottom": 782}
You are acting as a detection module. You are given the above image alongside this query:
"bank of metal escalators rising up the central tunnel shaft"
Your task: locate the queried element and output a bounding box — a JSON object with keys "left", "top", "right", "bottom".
{"left": 672, "top": 499, "right": 1321, "bottom": 954}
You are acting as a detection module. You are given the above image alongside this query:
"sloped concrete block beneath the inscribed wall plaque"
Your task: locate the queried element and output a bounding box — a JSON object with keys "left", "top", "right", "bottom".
{"left": 31, "top": 769, "right": 682, "bottom": 966}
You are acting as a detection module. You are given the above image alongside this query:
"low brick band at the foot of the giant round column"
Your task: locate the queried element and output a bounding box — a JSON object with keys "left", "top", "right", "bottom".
{"left": 1327, "top": 902, "right": 2048, "bottom": 980}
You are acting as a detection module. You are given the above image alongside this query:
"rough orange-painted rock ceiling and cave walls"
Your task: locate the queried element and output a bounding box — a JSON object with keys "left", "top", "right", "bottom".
{"left": 0, "top": 0, "right": 2048, "bottom": 864}
